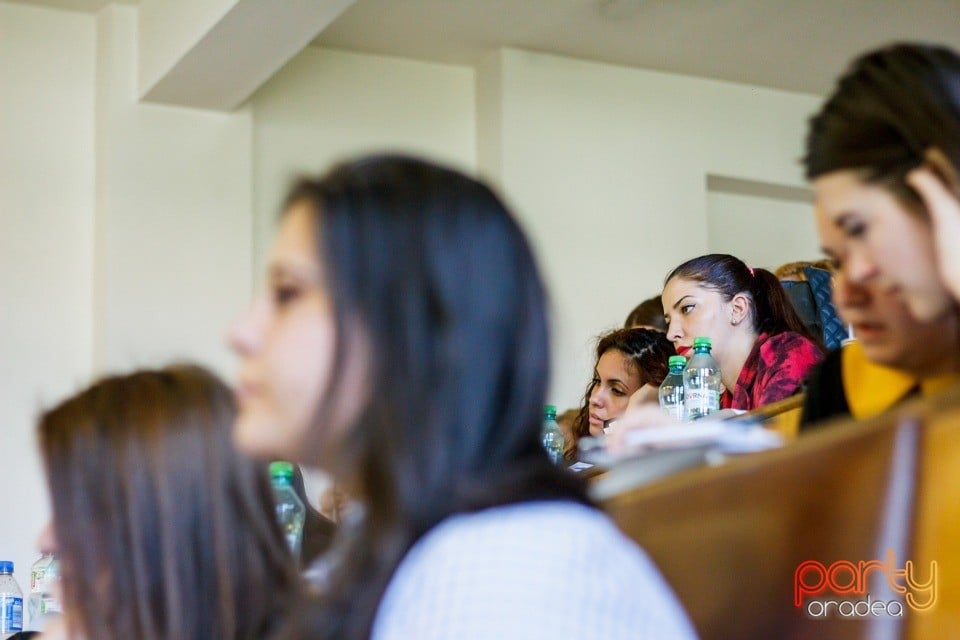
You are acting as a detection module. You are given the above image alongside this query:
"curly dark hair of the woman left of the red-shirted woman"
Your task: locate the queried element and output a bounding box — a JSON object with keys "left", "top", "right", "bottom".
{"left": 564, "top": 328, "right": 677, "bottom": 459}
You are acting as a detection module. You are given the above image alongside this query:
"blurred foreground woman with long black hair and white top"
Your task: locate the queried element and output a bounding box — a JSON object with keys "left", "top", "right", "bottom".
{"left": 231, "top": 156, "right": 695, "bottom": 640}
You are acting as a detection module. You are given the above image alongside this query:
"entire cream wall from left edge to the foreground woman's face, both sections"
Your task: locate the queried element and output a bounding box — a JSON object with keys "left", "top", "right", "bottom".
{"left": 0, "top": 3, "right": 253, "bottom": 608}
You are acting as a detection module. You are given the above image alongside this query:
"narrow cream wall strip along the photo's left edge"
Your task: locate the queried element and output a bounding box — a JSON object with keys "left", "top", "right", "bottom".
{"left": 0, "top": 3, "right": 95, "bottom": 600}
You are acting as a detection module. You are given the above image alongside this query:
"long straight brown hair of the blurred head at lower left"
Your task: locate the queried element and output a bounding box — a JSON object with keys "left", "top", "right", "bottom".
{"left": 38, "top": 366, "right": 298, "bottom": 640}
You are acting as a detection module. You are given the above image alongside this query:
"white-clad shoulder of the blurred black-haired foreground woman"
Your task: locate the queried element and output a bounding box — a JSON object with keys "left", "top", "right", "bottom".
{"left": 373, "top": 502, "right": 692, "bottom": 640}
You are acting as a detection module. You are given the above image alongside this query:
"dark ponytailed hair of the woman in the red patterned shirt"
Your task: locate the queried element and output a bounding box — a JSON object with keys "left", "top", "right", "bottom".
{"left": 664, "top": 253, "right": 823, "bottom": 349}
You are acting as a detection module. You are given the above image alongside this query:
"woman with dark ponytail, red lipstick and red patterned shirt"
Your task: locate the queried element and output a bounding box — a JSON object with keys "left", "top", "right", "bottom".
{"left": 662, "top": 254, "right": 823, "bottom": 411}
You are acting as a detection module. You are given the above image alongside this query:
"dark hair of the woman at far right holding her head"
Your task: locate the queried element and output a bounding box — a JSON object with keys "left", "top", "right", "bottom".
{"left": 803, "top": 44, "right": 960, "bottom": 211}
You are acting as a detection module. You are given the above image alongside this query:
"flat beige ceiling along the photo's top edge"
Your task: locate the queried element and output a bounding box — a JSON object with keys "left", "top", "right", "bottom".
{"left": 15, "top": 0, "right": 960, "bottom": 94}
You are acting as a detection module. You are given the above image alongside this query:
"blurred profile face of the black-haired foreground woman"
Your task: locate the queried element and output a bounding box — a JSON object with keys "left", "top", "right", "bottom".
{"left": 229, "top": 203, "right": 336, "bottom": 462}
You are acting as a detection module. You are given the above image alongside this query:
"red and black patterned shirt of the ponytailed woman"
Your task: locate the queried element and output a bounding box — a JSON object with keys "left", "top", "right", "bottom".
{"left": 720, "top": 331, "right": 824, "bottom": 411}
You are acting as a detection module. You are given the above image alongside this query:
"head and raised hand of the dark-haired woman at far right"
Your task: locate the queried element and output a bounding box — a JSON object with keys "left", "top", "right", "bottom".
{"left": 804, "top": 43, "right": 960, "bottom": 322}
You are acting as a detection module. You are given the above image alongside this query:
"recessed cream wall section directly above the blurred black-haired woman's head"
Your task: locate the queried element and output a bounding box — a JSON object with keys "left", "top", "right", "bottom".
{"left": 251, "top": 47, "right": 476, "bottom": 281}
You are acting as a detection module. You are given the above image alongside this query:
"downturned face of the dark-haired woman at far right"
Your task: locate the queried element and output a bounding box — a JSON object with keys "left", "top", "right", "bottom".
{"left": 813, "top": 170, "right": 952, "bottom": 322}
